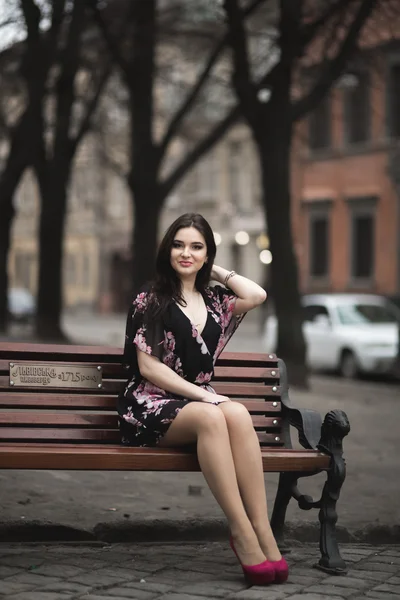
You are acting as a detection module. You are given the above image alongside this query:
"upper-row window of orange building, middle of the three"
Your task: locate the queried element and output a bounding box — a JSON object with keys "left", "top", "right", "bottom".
{"left": 343, "top": 71, "right": 371, "bottom": 144}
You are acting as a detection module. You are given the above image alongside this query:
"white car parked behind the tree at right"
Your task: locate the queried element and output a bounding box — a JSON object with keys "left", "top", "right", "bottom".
{"left": 264, "top": 294, "right": 400, "bottom": 378}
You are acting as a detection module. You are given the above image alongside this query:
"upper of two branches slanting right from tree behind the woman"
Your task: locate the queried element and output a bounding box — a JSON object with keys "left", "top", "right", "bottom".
{"left": 160, "top": 0, "right": 268, "bottom": 155}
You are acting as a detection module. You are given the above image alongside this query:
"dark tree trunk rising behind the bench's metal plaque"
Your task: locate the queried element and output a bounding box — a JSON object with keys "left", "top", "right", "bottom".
{"left": 36, "top": 164, "right": 70, "bottom": 342}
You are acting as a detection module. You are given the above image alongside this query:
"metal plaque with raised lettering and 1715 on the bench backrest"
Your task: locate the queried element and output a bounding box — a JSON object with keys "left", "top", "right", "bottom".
{"left": 10, "top": 363, "right": 102, "bottom": 389}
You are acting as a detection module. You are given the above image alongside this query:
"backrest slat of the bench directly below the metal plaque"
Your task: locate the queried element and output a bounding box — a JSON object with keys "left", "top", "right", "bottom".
{"left": 0, "top": 390, "right": 281, "bottom": 413}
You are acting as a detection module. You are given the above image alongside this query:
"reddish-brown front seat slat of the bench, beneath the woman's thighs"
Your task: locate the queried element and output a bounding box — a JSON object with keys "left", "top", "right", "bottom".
{"left": 0, "top": 444, "right": 330, "bottom": 472}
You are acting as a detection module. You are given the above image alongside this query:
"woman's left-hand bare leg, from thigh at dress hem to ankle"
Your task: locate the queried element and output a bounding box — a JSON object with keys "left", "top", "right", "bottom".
{"left": 159, "top": 402, "right": 265, "bottom": 565}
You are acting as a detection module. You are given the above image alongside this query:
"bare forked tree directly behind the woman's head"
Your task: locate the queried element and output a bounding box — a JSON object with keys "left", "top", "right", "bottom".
{"left": 92, "top": 0, "right": 266, "bottom": 289}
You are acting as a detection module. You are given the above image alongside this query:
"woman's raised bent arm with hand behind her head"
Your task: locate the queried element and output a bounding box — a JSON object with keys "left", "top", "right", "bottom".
{"left": 211, "top": 265, "right": 267, "bottom": 315}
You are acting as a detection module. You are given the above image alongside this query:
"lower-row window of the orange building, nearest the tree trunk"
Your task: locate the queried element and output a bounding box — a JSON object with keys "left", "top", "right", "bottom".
{"left": 309, "top": 200, "right": 332, "bottom": 278}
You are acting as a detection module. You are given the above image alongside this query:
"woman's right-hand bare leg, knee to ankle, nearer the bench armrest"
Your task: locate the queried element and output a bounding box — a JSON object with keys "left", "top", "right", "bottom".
{"left": 217, "top": 402, "right": 281, "bottom": 560}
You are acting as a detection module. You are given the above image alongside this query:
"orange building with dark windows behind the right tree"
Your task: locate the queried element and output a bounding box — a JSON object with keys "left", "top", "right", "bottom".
{"left": 292, "top": 42, "right": 400, "bottom": 295}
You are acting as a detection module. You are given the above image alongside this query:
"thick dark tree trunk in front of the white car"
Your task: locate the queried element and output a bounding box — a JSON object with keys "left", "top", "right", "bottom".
{"left": 255, "top": 94, "right": 307, "bottom": 387}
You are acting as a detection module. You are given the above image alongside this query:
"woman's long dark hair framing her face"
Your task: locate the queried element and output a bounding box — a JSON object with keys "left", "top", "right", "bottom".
{"left": 149, "top": 213, "right": 217, "bottom": 318}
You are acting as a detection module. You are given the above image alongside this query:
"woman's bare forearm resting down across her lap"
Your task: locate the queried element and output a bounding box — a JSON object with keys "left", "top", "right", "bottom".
{"left": 136, "top": 348, "right": 229, "bottom": 402}
